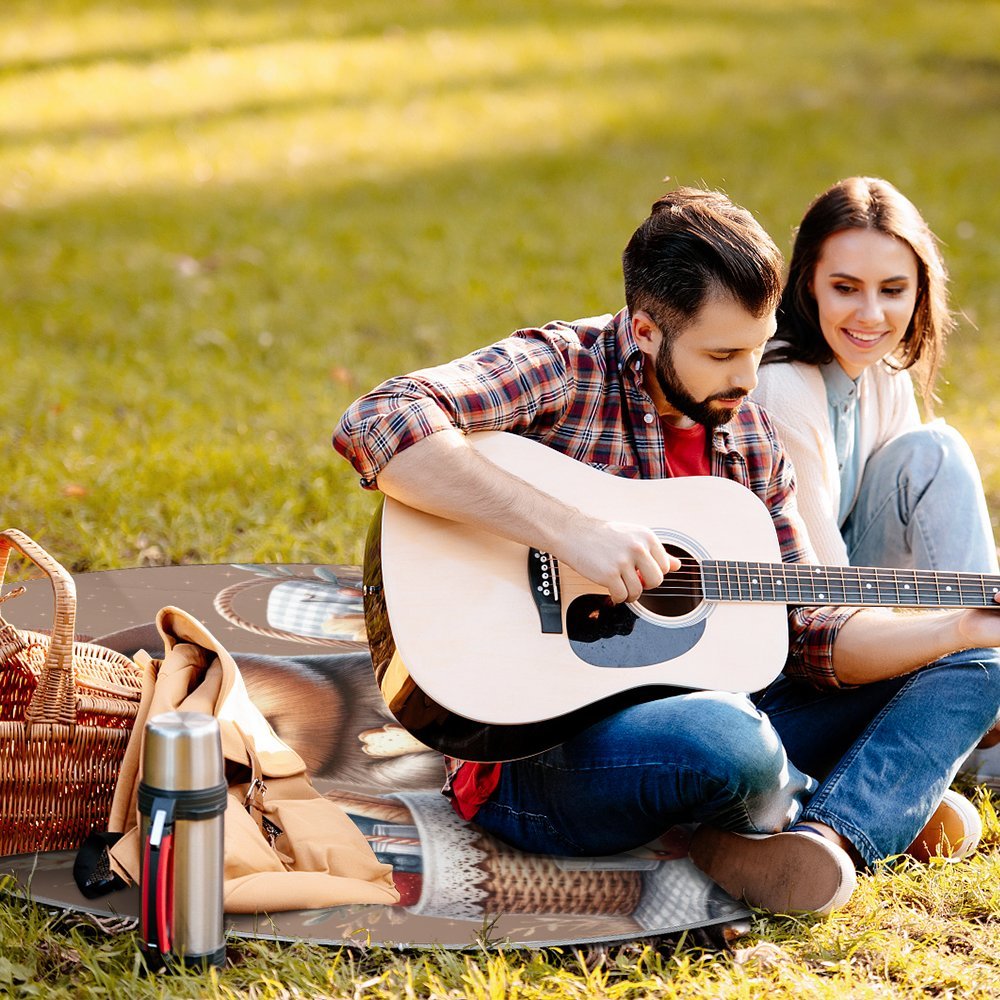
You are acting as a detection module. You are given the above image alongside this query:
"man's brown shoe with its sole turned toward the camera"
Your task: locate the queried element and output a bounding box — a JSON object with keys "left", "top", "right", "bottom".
{"left": 690, "top": 826, "right": 858, "bottom": 914}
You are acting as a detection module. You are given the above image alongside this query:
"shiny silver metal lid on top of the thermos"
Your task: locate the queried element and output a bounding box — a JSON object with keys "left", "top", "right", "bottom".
{"left": 142, "top": 712, "right": 225, "bottom": 791}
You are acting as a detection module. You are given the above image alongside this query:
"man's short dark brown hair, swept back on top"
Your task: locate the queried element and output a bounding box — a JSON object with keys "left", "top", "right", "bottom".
{"left": 622, "top": 188, "right": 782, "bottom": 341}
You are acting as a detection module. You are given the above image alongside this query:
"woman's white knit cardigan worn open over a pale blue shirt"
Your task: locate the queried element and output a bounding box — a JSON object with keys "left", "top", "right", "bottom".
{"left": 753, "top": 361, "right": 920, "bottom": 566}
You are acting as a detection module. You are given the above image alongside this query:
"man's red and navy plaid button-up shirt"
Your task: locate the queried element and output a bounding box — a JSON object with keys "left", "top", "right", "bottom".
{"left": 333, "top": 310, "right": 855, "bottom": 812}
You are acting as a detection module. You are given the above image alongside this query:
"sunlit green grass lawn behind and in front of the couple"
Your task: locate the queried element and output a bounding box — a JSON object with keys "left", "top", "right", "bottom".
{"left": 0, "top": 0, "right": 1000, "bottom": 998}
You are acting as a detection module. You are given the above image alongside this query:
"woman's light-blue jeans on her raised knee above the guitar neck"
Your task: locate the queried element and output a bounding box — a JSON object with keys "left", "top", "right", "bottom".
{"left": 841, "top": 422, "right": 997, "bottom": 573}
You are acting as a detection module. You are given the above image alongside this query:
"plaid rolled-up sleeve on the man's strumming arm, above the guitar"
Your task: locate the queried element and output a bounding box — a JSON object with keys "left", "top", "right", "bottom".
{"left": 333, "top": 330, "right": 573, "bottom": 489}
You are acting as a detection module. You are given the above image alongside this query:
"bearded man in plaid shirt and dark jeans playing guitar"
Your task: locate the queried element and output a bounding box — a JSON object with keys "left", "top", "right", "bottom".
{"left": 334, "top": 189, "right": 1000, "bottom": 913}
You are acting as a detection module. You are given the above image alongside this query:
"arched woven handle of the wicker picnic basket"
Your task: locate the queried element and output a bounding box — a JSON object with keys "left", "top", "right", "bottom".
{"left": 0, "top": 528, "right": 76, "bottom": 726}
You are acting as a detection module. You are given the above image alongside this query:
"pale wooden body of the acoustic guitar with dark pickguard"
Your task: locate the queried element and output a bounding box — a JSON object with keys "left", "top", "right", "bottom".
{"left": 365, "top": 433, "right": 788, "bottom": 760}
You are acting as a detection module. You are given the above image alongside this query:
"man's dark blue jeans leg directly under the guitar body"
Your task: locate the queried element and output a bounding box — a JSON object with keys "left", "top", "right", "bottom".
{"left": 475, "top": 691, "right": 816, "bottom": 856}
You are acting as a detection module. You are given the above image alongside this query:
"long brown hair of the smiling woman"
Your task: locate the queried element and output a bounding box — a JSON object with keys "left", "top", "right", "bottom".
{"left": 764, "top": 177, "right": 954, "bottom": 410}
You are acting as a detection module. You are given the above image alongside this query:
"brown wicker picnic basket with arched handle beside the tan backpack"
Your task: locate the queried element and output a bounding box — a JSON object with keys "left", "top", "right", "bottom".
{"left": 0, "top": 528, "right": 141, "bottom": 855}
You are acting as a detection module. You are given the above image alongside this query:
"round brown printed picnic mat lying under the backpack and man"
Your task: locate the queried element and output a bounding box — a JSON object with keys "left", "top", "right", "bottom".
{"left": 0, "top": 565, "right": 749, "bottom": 948}
